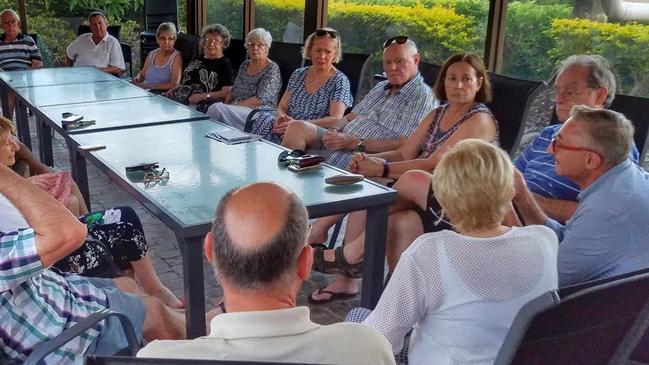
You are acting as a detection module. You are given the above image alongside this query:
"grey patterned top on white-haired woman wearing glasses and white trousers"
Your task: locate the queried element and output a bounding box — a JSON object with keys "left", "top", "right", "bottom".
{"left": 232, "top": 60, "right": 282, "bottom": 108}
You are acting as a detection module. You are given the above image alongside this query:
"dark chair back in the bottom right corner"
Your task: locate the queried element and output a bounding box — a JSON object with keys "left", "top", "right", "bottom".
{"left": 495, "top": 273, "right": 649, "bottom": 365}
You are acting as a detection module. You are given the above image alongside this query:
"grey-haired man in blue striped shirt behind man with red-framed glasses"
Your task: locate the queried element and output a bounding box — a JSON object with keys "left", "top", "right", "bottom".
{"left": 515, "top": 55, "right": 638, "bottom": 222}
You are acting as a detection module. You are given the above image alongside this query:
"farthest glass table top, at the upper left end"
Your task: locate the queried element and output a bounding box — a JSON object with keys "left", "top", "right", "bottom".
{"left": 0, "top": 67, "right": 117, "bottom": 87}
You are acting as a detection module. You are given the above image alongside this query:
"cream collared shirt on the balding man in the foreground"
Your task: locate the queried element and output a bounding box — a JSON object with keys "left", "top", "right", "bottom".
{"left": 138, "top": 307, "right": 394, "bottom": 365}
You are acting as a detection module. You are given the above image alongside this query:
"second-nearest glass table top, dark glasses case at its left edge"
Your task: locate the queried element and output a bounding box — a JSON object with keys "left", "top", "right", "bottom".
{"left": 39, "top": 95, "right": 207, "bottom": 133}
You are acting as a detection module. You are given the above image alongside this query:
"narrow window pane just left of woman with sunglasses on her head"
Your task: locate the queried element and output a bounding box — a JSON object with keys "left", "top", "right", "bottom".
{"left": 255, "top": 0, "right": 304, "bottom": 43}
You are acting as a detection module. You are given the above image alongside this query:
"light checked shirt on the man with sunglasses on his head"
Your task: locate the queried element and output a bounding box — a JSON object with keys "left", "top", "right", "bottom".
{"left": 327, "top": 74, "right": 439, "bottom": 168}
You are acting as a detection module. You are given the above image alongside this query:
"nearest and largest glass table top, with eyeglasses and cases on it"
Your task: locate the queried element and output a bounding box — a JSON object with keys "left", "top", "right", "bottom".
{"left": 70, "top": 120, "right": 392, "bottom": 226}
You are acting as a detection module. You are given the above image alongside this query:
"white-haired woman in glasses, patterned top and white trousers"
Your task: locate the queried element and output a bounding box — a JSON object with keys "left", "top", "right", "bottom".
{"left": 207, "top": 28, "right": 282, "bottom": 130}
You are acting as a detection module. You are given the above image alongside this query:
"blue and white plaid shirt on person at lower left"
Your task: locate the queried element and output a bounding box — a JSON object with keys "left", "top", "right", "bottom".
{"left": 0, "top": 228, "right": 108, "bottom": 364}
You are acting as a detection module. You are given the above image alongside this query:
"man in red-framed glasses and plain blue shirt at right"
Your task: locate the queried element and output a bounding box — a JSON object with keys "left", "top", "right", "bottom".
{"left": 514, "top": 105, "right": 649, "bottom": 286}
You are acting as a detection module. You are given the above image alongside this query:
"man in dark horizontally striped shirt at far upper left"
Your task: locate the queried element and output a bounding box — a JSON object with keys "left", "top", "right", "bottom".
{"left": 0, "top": 9, "right": 43, "bottom": 115}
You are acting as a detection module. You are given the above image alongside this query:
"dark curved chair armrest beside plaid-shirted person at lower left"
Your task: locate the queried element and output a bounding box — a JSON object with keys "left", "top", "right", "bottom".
{"left": 24, "top": 309, "right": 140, "bottom": 365}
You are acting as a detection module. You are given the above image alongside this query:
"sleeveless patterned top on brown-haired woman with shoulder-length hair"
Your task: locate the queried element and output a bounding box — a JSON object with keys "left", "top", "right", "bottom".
{"left": 419, "top": 103, "right": 499, "bottom": 158}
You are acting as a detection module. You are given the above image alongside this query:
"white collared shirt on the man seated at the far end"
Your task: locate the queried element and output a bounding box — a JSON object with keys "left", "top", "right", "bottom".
{"left": 65, "top": 33, "right": 126, "bottom": 70}
